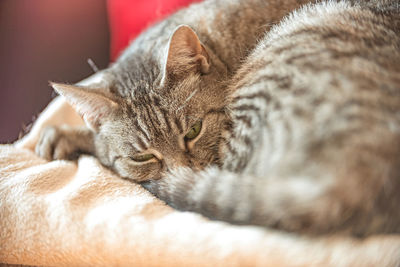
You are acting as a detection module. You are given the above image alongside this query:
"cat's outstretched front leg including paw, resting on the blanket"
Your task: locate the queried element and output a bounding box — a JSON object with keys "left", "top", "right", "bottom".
{"left": 35, "top": 125, "right": 94, "bottom": 160}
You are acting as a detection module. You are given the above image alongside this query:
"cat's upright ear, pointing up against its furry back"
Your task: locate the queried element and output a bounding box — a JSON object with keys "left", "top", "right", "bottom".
{"left": 165, "top": 25, "right": 210, "bottom": 77}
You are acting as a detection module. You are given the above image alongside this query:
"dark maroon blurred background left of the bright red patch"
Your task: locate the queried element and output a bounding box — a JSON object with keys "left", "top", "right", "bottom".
{"left": 0, "top": 0, "right": 109, "bottom": 143}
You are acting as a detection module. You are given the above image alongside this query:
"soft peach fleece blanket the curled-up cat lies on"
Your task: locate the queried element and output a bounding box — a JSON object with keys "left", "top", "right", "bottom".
{"left": 0, "top": 73, "right": 400, "bottom": 267}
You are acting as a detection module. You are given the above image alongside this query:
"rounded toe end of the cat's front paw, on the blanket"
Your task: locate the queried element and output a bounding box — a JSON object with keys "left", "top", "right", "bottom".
{"left": 35, "top": 126, "right": 79, "bottom": 160}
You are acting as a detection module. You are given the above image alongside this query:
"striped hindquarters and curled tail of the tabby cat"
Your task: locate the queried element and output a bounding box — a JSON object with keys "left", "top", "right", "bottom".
{"left": 141, "top": 2, "right": 400, "bottom": 236}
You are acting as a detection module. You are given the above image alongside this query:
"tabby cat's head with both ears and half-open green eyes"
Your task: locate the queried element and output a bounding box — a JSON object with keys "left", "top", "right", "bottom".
{"left": 53, "top": 26, "right": 229, "bottom": 181}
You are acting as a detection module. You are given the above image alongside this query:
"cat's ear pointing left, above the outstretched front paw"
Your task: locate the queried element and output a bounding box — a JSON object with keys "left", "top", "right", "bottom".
{"left": 50, "top": 83, "right": 118, "bottom": 132}
